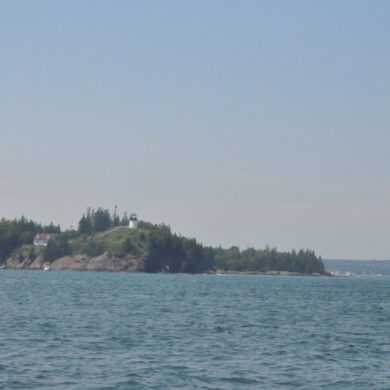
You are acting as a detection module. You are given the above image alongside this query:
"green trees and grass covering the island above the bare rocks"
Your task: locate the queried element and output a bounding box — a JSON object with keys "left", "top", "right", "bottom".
{"left": 0, "top": 208, "right": 325, "bottom": 274}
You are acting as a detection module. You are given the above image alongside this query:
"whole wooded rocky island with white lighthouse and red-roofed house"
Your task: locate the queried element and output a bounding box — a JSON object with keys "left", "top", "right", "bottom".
{"left": 0, "top": 208, "right": 329, "bottom": 276}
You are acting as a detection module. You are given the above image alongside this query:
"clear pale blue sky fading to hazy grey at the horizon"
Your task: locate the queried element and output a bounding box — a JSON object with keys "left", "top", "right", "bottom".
{"left": 0, "top": 0, "right": 390, "bottom": 259}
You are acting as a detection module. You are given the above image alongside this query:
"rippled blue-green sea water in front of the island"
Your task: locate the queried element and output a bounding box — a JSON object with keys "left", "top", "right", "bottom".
{"left": 0, "top": 270, "right": 390, "bottom": 390}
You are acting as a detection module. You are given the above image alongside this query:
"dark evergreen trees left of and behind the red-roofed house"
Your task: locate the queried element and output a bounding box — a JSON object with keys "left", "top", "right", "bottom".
{"left": 0, "top": 217, "right": 61, "bottom": 262}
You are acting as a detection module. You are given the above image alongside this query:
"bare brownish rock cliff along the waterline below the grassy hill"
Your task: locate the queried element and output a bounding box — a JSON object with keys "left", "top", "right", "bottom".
{"left": 3, "top": 253, "right": 146, "bottom": 272}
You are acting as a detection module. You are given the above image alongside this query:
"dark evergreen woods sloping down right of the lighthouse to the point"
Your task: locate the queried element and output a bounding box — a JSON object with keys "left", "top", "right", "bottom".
{"left": 133, "top": 221, "right": 325, "bottom": 274}
